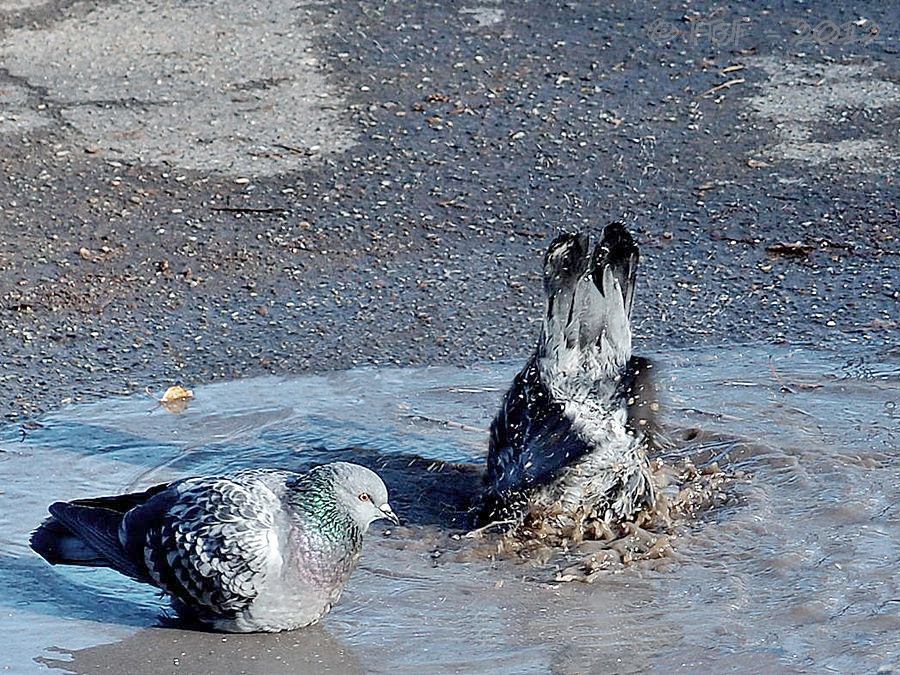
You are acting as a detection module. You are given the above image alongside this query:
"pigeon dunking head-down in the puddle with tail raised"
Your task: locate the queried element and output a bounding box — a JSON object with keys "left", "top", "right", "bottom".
{"left": 476, "top": 223, "right": 654, "bottom": 524}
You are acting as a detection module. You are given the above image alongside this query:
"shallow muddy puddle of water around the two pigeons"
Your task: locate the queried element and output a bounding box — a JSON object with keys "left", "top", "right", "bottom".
{"left": 0, "top": 348, "right": 900, "bottom": 674}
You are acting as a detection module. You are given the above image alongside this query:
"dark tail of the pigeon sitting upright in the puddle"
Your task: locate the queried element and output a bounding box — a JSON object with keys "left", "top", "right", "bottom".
{"left": 30, "top": 485, "right": 166, "bottom": 580}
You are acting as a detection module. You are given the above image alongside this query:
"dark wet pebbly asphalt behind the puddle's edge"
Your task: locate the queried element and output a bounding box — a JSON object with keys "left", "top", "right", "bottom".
{"left": 0, "top": 0, "right": 900, "bottom": 421}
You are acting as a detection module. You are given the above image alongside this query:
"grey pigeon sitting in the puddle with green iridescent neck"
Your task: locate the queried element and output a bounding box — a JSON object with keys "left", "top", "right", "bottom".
{"left": 31, "top": 462, "right": 398, "bottom": 633}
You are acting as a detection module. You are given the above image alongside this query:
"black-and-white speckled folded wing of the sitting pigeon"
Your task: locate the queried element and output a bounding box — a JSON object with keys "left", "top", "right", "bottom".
{"left": 122, "top": 470, "right": 284, "bottom": 619}
